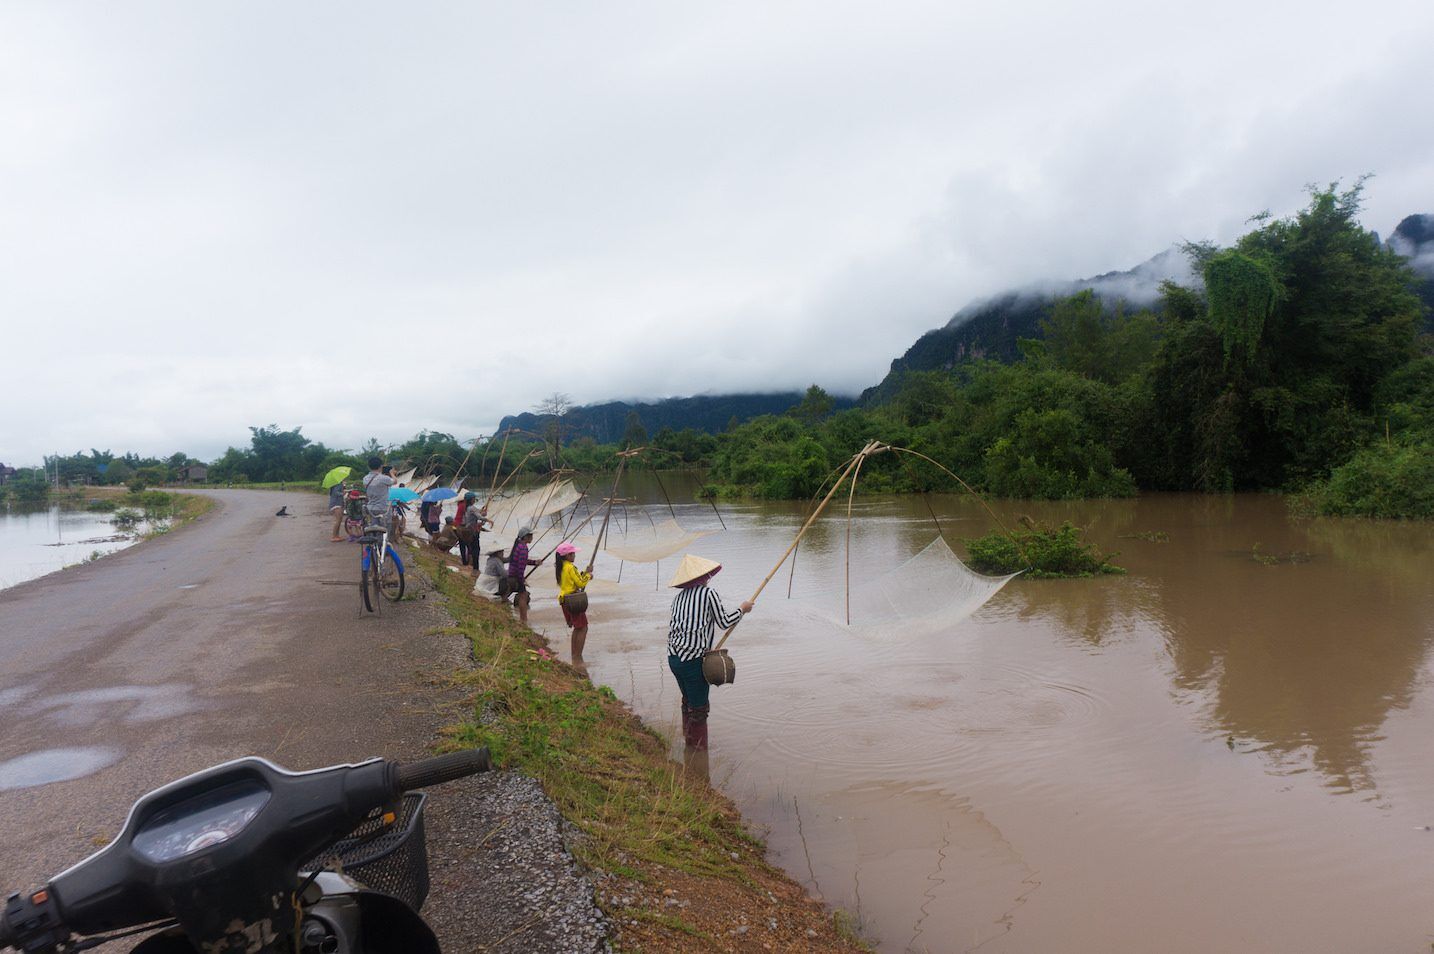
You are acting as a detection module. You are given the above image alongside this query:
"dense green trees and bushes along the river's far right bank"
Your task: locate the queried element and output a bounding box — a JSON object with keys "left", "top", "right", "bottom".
{"left": 710, "top": 182, "right": 1434, "bottom": 515}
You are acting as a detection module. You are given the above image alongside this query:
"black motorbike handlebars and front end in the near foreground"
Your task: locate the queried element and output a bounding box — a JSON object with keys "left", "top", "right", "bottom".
{"left": 0, "top": 749, "right": 490, "bottom": 954}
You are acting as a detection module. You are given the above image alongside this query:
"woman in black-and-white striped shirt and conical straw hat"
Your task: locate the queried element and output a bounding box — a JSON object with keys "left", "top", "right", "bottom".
{"left": 667, "top": 554, "right": 751, "bottom": 749}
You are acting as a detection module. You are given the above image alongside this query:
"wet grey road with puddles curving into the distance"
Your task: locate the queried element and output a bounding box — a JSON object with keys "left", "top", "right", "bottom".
{"left": 0, "top": 491, "right": 455, "bottom": 894}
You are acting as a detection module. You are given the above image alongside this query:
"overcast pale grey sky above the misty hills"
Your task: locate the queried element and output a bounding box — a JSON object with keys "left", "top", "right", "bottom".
{"left": 0, "top": 0, "right": 1434, "bottom": 463}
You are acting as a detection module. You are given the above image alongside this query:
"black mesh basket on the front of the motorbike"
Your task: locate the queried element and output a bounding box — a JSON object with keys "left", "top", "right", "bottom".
{"left": 301, "top": 792, "right": 429, "bottom": 911}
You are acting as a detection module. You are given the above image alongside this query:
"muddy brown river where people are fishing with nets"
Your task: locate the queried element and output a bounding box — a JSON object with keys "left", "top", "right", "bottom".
{"left": 533, "top": 479, "right": 1434, "bottom": 954}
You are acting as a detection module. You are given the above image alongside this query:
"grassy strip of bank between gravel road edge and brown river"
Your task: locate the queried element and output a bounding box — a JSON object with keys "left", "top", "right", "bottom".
{"left": 416, "top": 551, "right": 866, "bottom": 951}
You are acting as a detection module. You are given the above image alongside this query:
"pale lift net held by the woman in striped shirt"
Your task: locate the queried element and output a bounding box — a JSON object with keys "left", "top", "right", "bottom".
{"left": 800, "top": 537, "right": 1020, "bottom": 634}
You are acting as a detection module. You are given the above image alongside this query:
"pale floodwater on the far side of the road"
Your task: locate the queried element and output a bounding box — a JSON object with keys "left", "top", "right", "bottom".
{"left": 0, "top": 504, "right": 138, "bottom": 590}
